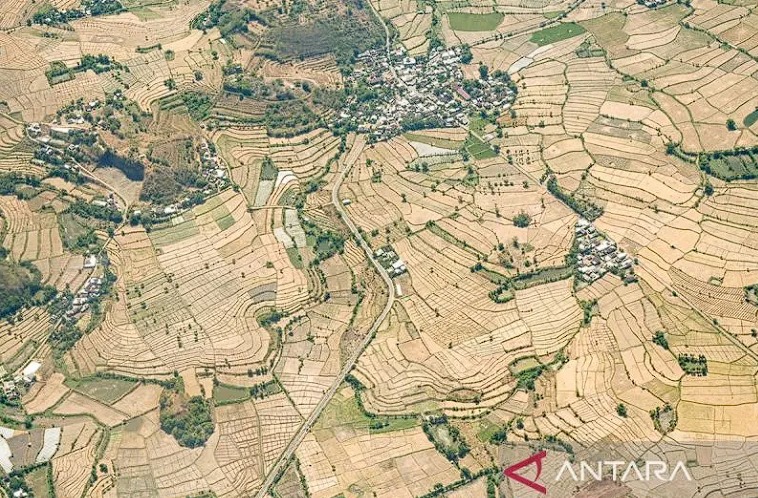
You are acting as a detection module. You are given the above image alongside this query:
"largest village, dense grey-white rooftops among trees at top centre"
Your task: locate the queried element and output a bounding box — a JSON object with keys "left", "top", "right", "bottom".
{"left": 336, "top": 47, "right": 515, "bottom": 141}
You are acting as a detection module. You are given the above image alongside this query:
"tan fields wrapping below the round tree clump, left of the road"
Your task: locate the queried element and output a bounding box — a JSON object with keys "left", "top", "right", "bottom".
{"left": 99, "top": 394, "right": 302, "bottom": 497}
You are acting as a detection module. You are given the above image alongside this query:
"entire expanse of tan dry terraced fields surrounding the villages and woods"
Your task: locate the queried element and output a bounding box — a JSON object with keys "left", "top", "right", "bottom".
{"left": 0, "top": 0, "right": 758, "bottom": 498}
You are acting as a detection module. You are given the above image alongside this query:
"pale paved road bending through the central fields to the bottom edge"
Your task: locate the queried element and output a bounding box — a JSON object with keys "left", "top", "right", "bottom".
{"left": 255, "top": 138, "right": 395, "bottom": 498}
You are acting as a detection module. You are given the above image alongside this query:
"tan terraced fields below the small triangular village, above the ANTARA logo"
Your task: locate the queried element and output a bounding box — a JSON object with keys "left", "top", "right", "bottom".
{"left": 488, "top": 276, "right": 758, "bottom": 464}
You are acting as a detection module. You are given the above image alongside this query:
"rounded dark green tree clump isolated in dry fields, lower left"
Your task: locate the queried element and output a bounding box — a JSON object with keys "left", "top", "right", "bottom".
{"left": 160, "top": 390, "right": 213, "bottom": 448}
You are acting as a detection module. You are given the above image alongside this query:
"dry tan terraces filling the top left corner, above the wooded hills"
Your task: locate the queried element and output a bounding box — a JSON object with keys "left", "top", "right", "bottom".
{"left": 0, "top": 2, "right": 217, "bottom": 121}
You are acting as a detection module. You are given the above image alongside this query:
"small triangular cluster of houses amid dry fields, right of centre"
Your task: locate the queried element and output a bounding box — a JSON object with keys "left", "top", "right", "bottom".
{"left": 575, "top": 218, "right": 634, "bottom": 282}
